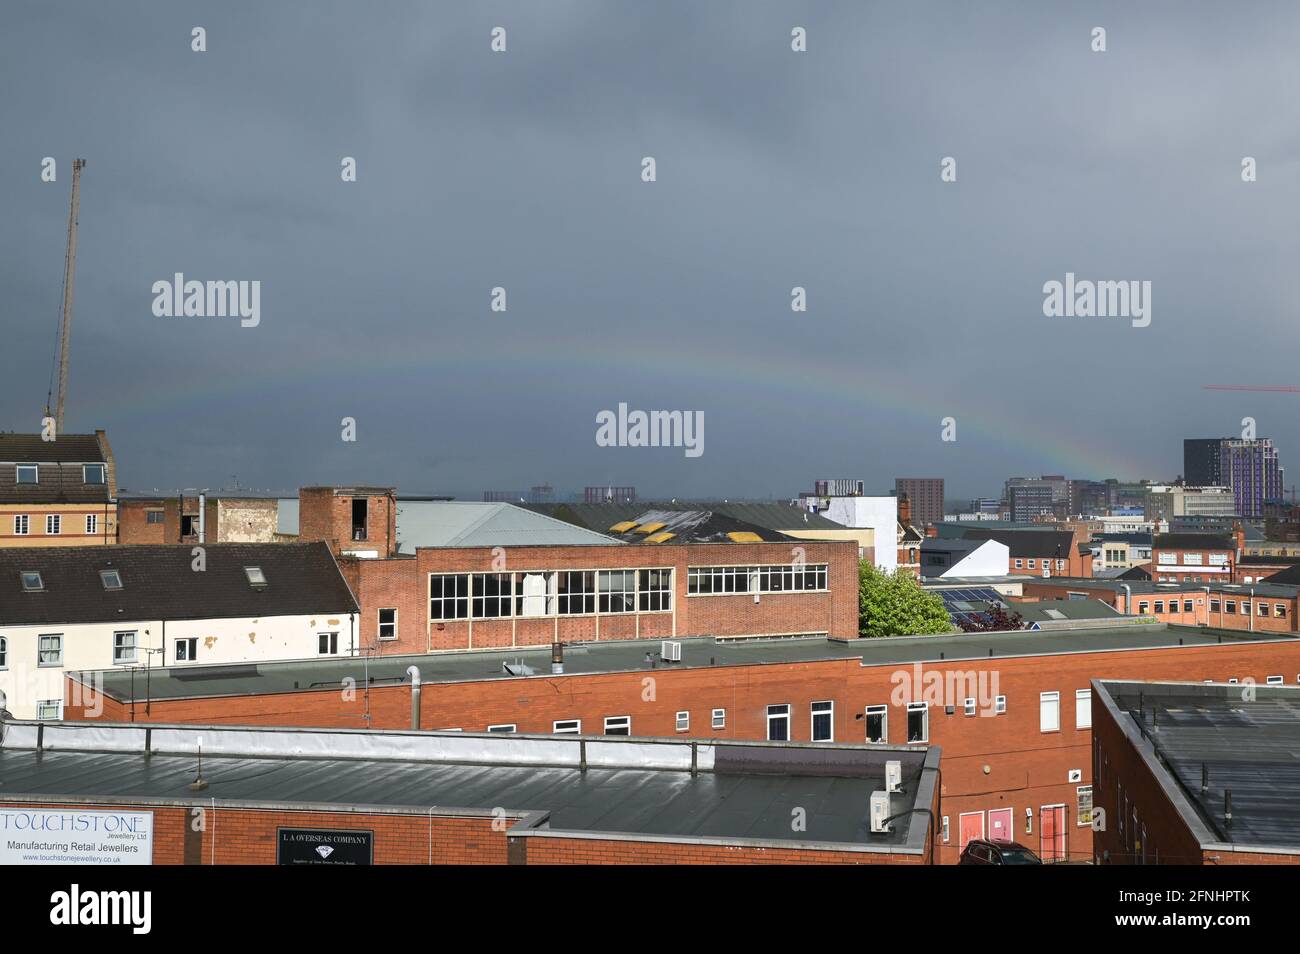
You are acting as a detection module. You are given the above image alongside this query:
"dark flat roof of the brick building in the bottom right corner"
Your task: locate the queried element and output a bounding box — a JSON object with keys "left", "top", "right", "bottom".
{"left": 1093, "top": 673, "right": 1300, "bottom": 853}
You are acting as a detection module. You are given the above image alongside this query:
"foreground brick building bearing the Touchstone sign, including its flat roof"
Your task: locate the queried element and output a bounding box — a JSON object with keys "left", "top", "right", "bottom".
{"left": 0, "top": 723, "right": 940, "bottom": 864}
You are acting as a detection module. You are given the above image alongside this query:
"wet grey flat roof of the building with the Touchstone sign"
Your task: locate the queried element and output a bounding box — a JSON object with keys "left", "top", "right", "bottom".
{"left": 0, "top": 723, "right": 940, "bottom": 854}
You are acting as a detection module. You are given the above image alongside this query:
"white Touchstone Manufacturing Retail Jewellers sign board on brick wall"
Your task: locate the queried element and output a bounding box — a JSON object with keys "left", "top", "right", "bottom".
{"left": 0, "top": 808, "right": 153, "bottom": 864}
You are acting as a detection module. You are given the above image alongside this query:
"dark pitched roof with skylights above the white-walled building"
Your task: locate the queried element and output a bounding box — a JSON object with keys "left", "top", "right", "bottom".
{"left": 0, "top": 542, "right": 358, "bottom": 625}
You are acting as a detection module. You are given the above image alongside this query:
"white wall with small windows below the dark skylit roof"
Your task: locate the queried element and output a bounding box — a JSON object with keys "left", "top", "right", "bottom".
{"left": 0, "top": 613, "right": 356, "bottom": 719}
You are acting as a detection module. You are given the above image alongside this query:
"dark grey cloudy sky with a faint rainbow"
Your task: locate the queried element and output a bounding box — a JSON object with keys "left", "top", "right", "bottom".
{"left": 0, "top": 0, "right": 1300, "bottom": 496}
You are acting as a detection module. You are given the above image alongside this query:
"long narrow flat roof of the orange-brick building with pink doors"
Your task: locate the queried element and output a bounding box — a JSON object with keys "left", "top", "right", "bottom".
{"left": 73, "top": 616, "right": 1295, "bottom": 702}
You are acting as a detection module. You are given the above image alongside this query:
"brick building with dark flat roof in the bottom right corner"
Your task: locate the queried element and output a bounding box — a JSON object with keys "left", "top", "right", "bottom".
{"left": 1092, "top": 681, "right": 1300, "bottom": 866}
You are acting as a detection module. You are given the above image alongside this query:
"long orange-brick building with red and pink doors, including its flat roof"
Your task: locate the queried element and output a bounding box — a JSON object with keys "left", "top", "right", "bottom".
{"left": 65, "top": 623, "right": 1300, "bottom": 862}
